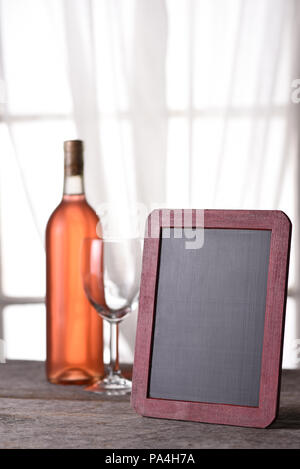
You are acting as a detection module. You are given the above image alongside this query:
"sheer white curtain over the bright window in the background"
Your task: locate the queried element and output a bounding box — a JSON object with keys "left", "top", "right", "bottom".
{"left": 0, "top": 0, "right": 300, "bottom": 367}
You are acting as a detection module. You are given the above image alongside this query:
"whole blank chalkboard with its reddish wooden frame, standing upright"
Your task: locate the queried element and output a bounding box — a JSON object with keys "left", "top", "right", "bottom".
{"left": 132, "top": 210, "right": 291, "bottom": 428}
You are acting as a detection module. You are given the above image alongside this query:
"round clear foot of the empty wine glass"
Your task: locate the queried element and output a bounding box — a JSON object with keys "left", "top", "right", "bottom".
{"left": 84, "top": 373, "right": 131, "bottom": 396}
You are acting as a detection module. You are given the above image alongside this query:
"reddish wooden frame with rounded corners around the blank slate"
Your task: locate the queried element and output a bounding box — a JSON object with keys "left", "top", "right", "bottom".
{"left": 131, "top": 210, "right": 291, "bottom": 428}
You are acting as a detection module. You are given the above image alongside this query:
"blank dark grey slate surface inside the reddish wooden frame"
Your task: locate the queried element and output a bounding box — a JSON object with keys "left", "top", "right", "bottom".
{"left": 149, "top": 228, "right": 271, "bottom": 406}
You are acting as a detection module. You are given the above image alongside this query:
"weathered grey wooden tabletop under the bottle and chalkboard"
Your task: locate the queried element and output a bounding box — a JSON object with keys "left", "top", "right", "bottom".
{"left": 0, "top": 361, "right": 300, "bottom": 449}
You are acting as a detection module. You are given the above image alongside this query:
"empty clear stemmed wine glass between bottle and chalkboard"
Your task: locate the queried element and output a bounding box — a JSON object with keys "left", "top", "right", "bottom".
{"left": 81, "top": 238, "right": 142, "bottom": 395}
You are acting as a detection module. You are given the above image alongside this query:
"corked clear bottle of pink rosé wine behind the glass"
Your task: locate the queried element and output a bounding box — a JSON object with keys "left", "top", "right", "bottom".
{"left": 46, "top": 140, "right": 104, "bottom": 384}
